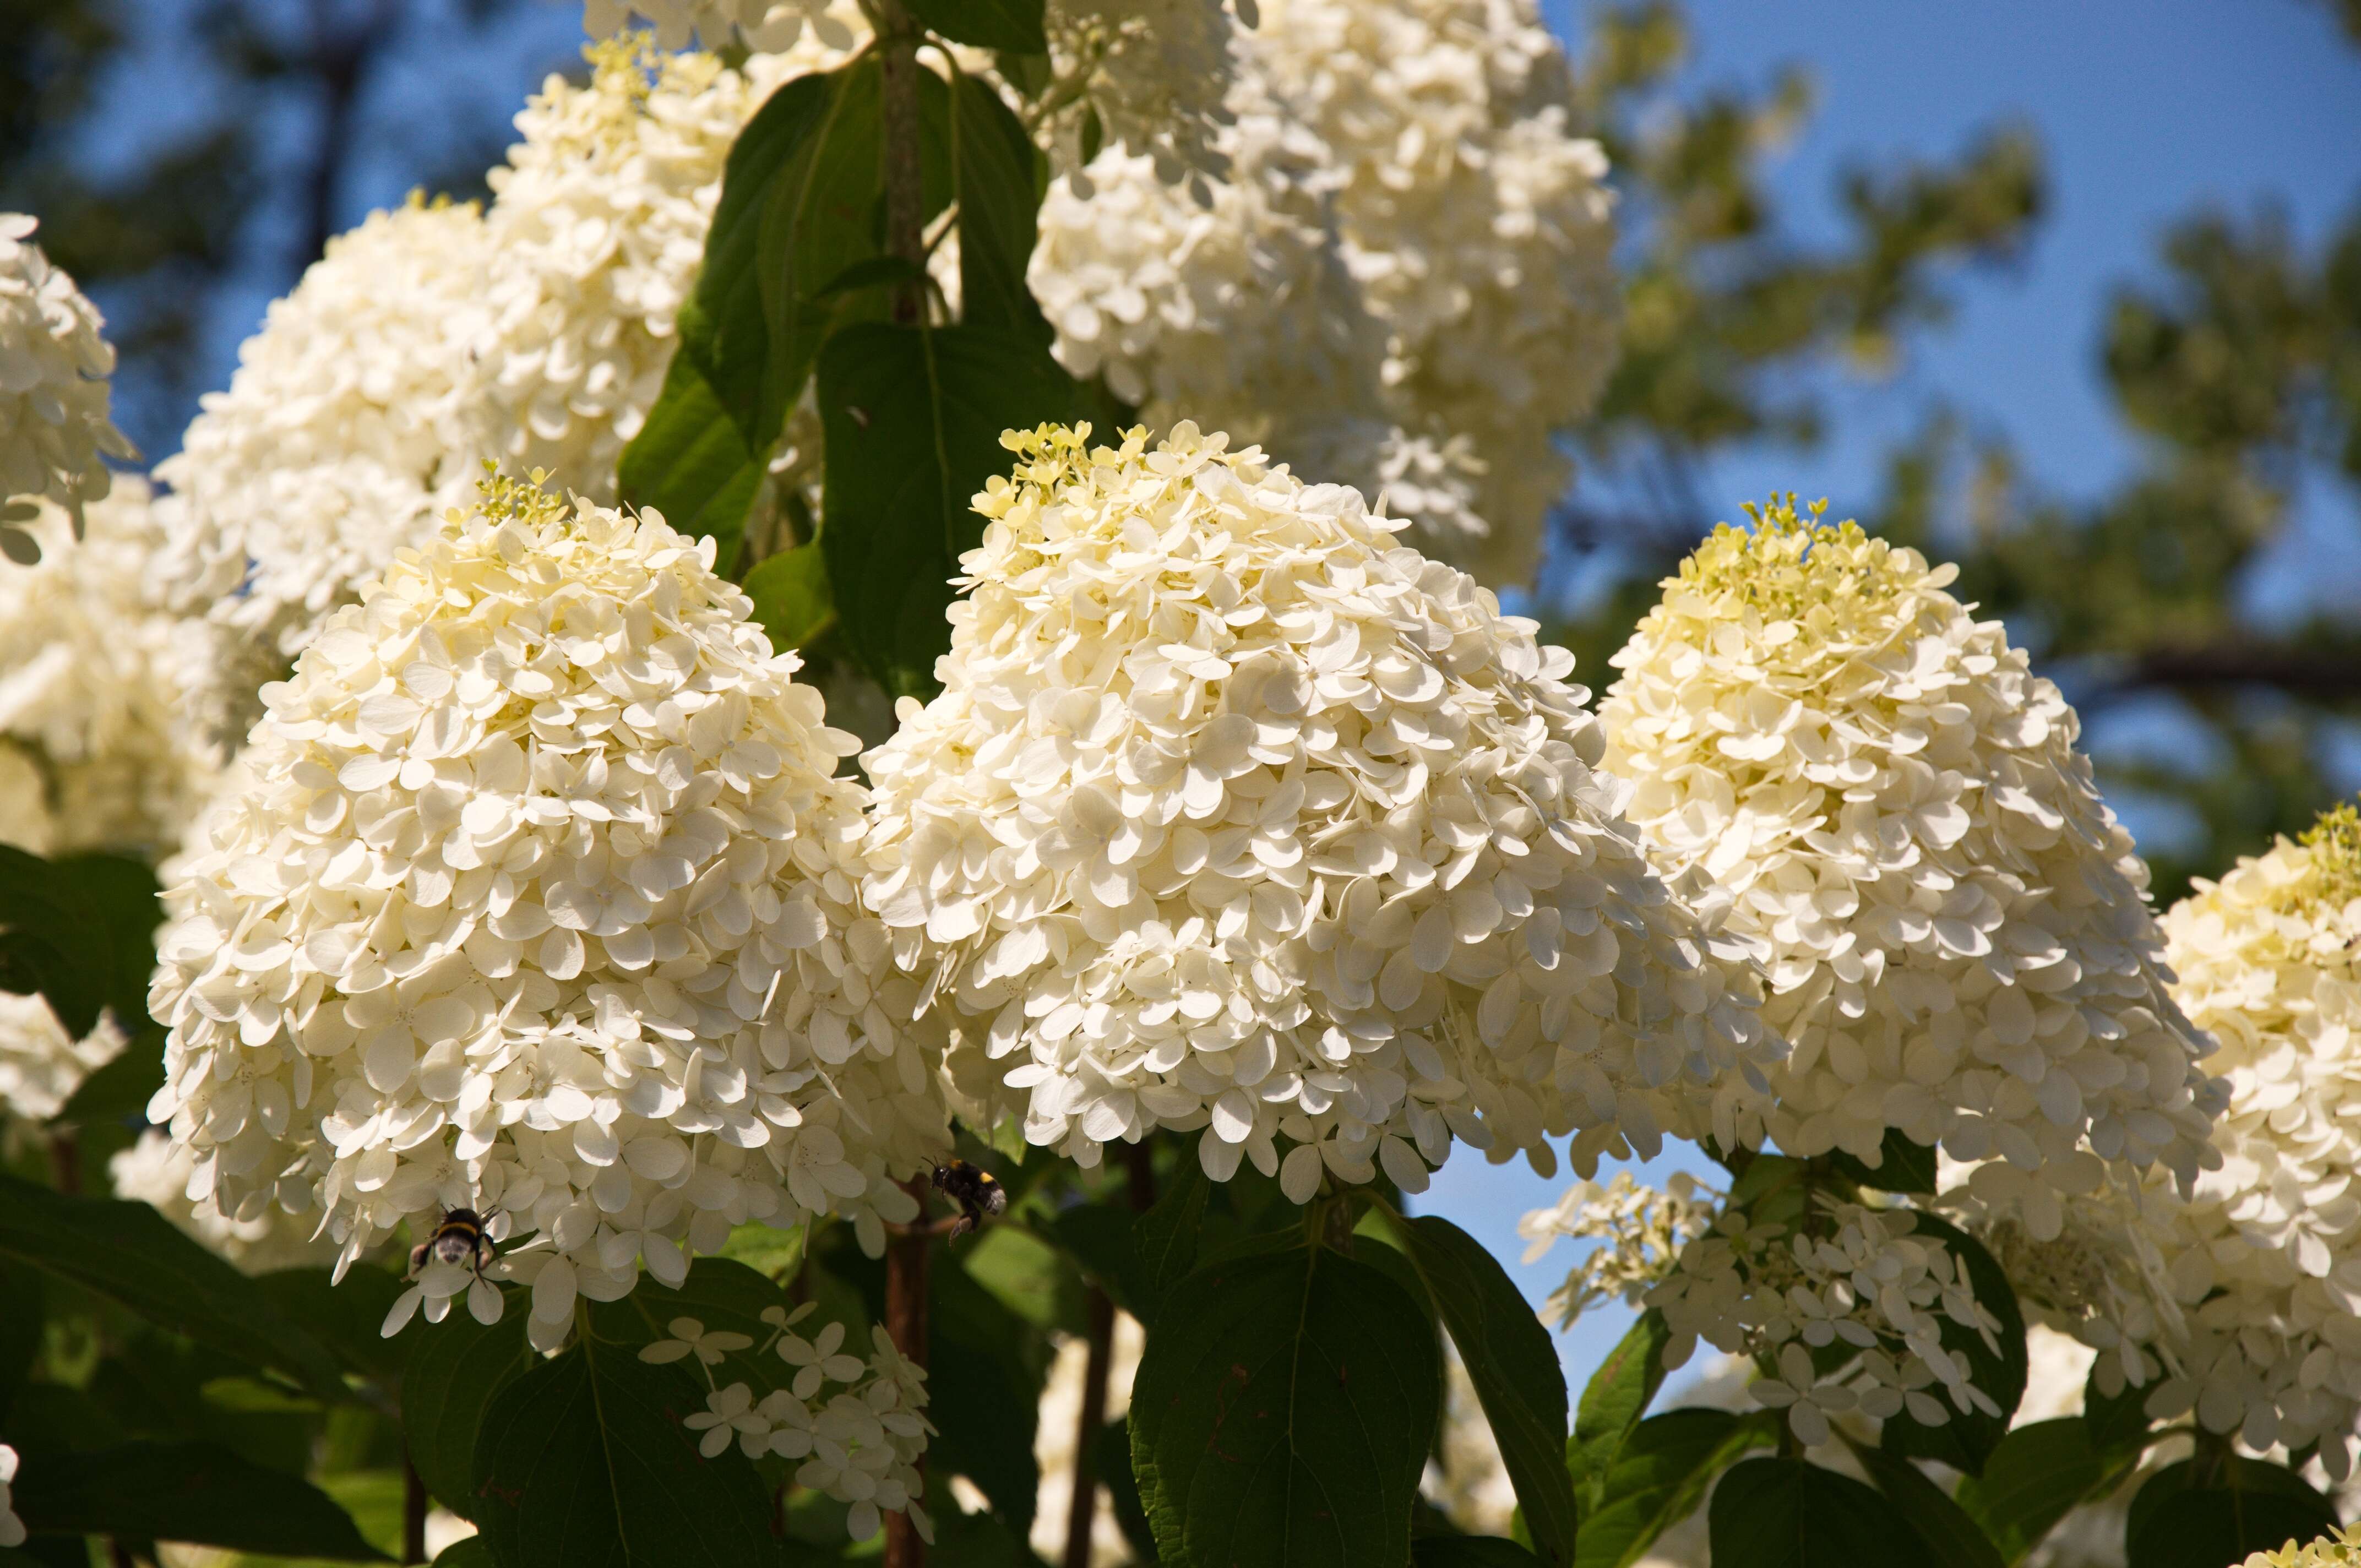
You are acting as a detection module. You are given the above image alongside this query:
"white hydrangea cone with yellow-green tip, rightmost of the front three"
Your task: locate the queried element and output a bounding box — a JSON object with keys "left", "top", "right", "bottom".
{"left": 1601, "top": 503, "right": 2219, "bottom": 1195}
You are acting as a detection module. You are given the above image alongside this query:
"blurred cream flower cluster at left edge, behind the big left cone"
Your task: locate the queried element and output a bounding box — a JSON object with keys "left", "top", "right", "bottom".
{"left": 0, "top": 477, "right": 217, "bottom": 855}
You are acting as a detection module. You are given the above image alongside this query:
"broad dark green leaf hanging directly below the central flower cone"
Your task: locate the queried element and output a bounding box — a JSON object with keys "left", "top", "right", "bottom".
{"left": 1131, "top": 1247, "right": 1440, "bottom": 1568}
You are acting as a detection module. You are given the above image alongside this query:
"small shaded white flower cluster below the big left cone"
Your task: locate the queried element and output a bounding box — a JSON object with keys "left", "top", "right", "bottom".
{"left": 640, "top": 1301, "right": 935, "bottom": 1542}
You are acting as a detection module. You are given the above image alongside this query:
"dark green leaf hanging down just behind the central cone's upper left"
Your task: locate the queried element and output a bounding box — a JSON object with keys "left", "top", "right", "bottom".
{"left": 819, "top": 324, "right": 1076, "bottom": 694}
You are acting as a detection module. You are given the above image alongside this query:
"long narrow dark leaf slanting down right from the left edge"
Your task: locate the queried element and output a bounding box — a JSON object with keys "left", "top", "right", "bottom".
{"left": 0, "top": 1176, "right": 350, "bottom": 1400}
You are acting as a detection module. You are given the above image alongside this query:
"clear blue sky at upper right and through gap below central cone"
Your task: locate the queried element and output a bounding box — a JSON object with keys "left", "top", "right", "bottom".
{"left": 1424, "top": 0, "right": 2361, "bottom": 1389}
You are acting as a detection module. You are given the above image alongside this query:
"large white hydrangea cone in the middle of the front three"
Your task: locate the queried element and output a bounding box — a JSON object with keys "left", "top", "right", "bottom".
{"left": 864, "top": 423, "right": 1778, "bottom": 1202}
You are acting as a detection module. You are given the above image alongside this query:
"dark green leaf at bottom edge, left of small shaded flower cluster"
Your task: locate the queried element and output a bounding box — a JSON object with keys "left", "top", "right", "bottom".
{"left": 475, "top": 1332, "right": 781, "bottom": 1568}
